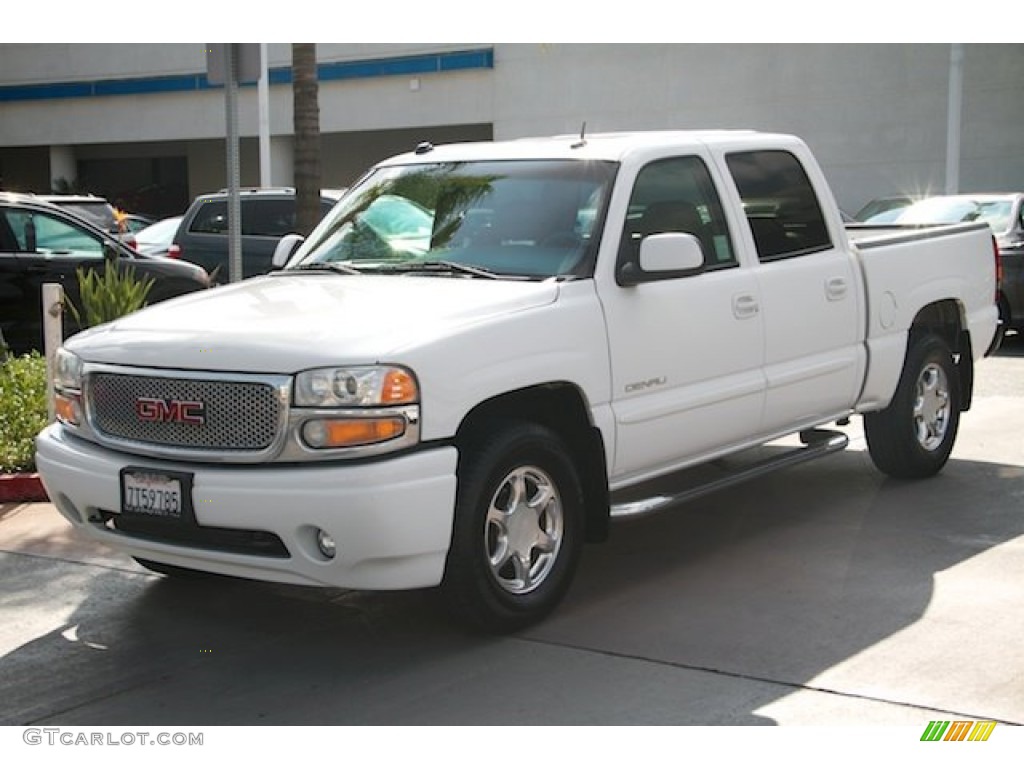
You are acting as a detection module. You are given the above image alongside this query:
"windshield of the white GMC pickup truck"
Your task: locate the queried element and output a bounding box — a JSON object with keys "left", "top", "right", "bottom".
{"left": 291, "top": 160, "right": 615, "bottom": 279}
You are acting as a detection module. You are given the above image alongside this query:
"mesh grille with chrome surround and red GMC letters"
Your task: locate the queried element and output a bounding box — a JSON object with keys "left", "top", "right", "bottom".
{"left": 86, "top": 372, "right": 284, "bottom": 452}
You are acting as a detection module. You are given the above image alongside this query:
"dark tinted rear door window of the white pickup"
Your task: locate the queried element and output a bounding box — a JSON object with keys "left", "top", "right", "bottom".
{"left": 726, "top": 150, "right": 831, "bottom": 261}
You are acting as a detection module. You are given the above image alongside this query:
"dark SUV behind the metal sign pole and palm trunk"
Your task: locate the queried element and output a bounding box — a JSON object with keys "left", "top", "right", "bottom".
{"left": 170, "top": 187, "right": 343, "bottom": 283}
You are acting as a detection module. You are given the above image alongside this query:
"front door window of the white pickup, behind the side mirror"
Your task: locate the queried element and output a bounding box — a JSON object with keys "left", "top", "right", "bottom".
{"left": 618, "top": 157, "right": 736, "bottom": 276}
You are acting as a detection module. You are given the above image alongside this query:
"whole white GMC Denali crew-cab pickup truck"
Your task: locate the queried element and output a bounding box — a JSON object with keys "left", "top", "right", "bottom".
{"left": 37, "top": 131, "right": 997, "bottom": 631}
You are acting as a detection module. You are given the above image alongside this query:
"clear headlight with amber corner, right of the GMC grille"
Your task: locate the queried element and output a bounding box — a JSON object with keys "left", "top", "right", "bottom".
{"left": 295, "top": 366, "right": 420, "bottom": 408}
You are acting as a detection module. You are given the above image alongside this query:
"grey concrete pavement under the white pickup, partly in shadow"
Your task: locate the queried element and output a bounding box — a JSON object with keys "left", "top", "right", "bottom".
{"left": 0, "top": 338, "right": 1024, "bottom": 729}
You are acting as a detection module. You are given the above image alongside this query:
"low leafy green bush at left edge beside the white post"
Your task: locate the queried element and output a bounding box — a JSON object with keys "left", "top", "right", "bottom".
{"left": 0, "top": 352, "right": 47, "bottom": 472}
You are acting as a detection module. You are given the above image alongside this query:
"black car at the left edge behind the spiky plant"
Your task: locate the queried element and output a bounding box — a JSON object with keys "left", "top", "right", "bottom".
{"left": 0, "top": 193, "right": 210, "bottom": 353}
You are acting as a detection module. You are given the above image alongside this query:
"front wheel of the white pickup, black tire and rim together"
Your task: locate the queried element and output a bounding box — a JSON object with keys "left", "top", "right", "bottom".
{"left": 441, "top": 424, "right": 584, "bottom": 632}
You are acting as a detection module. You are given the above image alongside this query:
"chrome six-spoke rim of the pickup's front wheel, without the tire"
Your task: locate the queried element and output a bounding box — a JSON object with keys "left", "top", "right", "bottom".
{"left": 484, "top": 467, "right": 564, "bottom": 595}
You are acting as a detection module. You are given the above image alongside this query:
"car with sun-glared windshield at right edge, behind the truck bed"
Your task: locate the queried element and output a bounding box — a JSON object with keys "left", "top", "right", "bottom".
{"left": 868, "top": 193, "right": 1024, "bottom": 331}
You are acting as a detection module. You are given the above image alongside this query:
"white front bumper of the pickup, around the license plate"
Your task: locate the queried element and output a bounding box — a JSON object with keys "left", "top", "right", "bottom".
{"left": 36, "top": 424, "right": 457, "bottom": 590}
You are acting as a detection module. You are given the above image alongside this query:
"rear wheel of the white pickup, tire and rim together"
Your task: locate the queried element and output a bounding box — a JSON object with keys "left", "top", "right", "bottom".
{"left": 864, "top": 335, "right": 961, "bottom": 479}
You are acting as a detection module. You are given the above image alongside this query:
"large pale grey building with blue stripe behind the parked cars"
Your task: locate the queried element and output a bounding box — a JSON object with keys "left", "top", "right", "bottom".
{"left": 0, "top": 43, "right": 1024, "bottom": 215}
